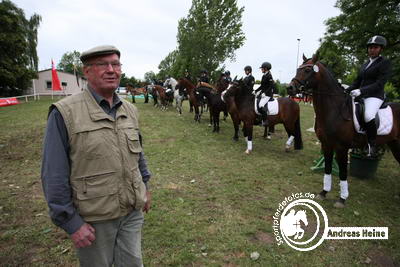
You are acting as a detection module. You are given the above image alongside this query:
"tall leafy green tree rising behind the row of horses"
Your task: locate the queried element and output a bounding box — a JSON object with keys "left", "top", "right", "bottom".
{"left": 159, "top": 0, "right": 245, "bottom": 79}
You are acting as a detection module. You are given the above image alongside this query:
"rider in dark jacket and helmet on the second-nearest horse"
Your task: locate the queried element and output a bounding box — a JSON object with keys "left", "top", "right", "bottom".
{"left": 254, "top": 62, "right": 274, "bottom": 126}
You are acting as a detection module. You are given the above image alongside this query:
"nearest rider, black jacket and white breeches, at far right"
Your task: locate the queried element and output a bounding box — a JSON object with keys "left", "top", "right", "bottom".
{"left": 347, "top": 35, "right": 391, "bottom": 156}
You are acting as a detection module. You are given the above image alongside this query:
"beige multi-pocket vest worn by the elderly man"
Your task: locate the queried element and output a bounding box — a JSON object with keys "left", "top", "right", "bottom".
{"left": 54, "top": 90, "right": 146, "bottom": 222}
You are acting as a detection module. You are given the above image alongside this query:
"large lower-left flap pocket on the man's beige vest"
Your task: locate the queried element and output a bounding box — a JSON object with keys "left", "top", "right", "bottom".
{"left": 75, "top": 171, "right": 119, "bottom": 221}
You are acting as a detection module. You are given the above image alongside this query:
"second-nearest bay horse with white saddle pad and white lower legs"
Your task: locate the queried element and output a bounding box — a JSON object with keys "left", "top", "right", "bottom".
{"left": 223, "top": 79, "right": 303, "bottom": 154}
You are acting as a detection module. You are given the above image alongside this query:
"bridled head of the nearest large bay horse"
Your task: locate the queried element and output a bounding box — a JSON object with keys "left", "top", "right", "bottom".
{"left": 286, "top": 53, "right": 321, "bottom": 96}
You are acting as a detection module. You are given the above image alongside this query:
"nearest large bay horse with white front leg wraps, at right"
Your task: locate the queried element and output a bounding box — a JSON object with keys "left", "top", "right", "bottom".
{"left": 287, "top": 54, "right": 400, "bottom": 208}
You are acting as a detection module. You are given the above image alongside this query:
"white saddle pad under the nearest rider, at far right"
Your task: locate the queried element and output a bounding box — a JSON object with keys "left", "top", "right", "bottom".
{"left": 353, "top": 98, "right": 393, "bottom": 135}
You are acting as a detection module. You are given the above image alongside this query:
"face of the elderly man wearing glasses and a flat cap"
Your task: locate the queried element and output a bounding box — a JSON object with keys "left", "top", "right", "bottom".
{"left": 83, "top": 54, "right": 121, "bottom": 94}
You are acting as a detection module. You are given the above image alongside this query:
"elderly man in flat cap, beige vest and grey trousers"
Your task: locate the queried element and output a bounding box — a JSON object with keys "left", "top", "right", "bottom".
{"left": 42, "top": 45, "right": 150, "bottom": 266}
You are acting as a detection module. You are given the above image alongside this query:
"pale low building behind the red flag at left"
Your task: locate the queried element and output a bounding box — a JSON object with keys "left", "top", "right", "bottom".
{"left": 29, "top": 69, "right": 87, "bottom": 95}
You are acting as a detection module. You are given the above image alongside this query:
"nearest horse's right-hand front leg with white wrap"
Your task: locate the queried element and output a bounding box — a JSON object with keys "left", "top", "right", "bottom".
{"left": 334, "top": 148, "right": 349, "bottom": 208}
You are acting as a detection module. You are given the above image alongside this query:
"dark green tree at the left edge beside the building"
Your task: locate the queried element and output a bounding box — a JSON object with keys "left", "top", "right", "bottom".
{"left": 0, "top": 0, "right": 41, "bottom": 96}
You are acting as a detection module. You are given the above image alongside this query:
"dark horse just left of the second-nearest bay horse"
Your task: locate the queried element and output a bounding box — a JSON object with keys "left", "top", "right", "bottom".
{"left": 197, "top": 75, "right": 229, "bottom": 133}
